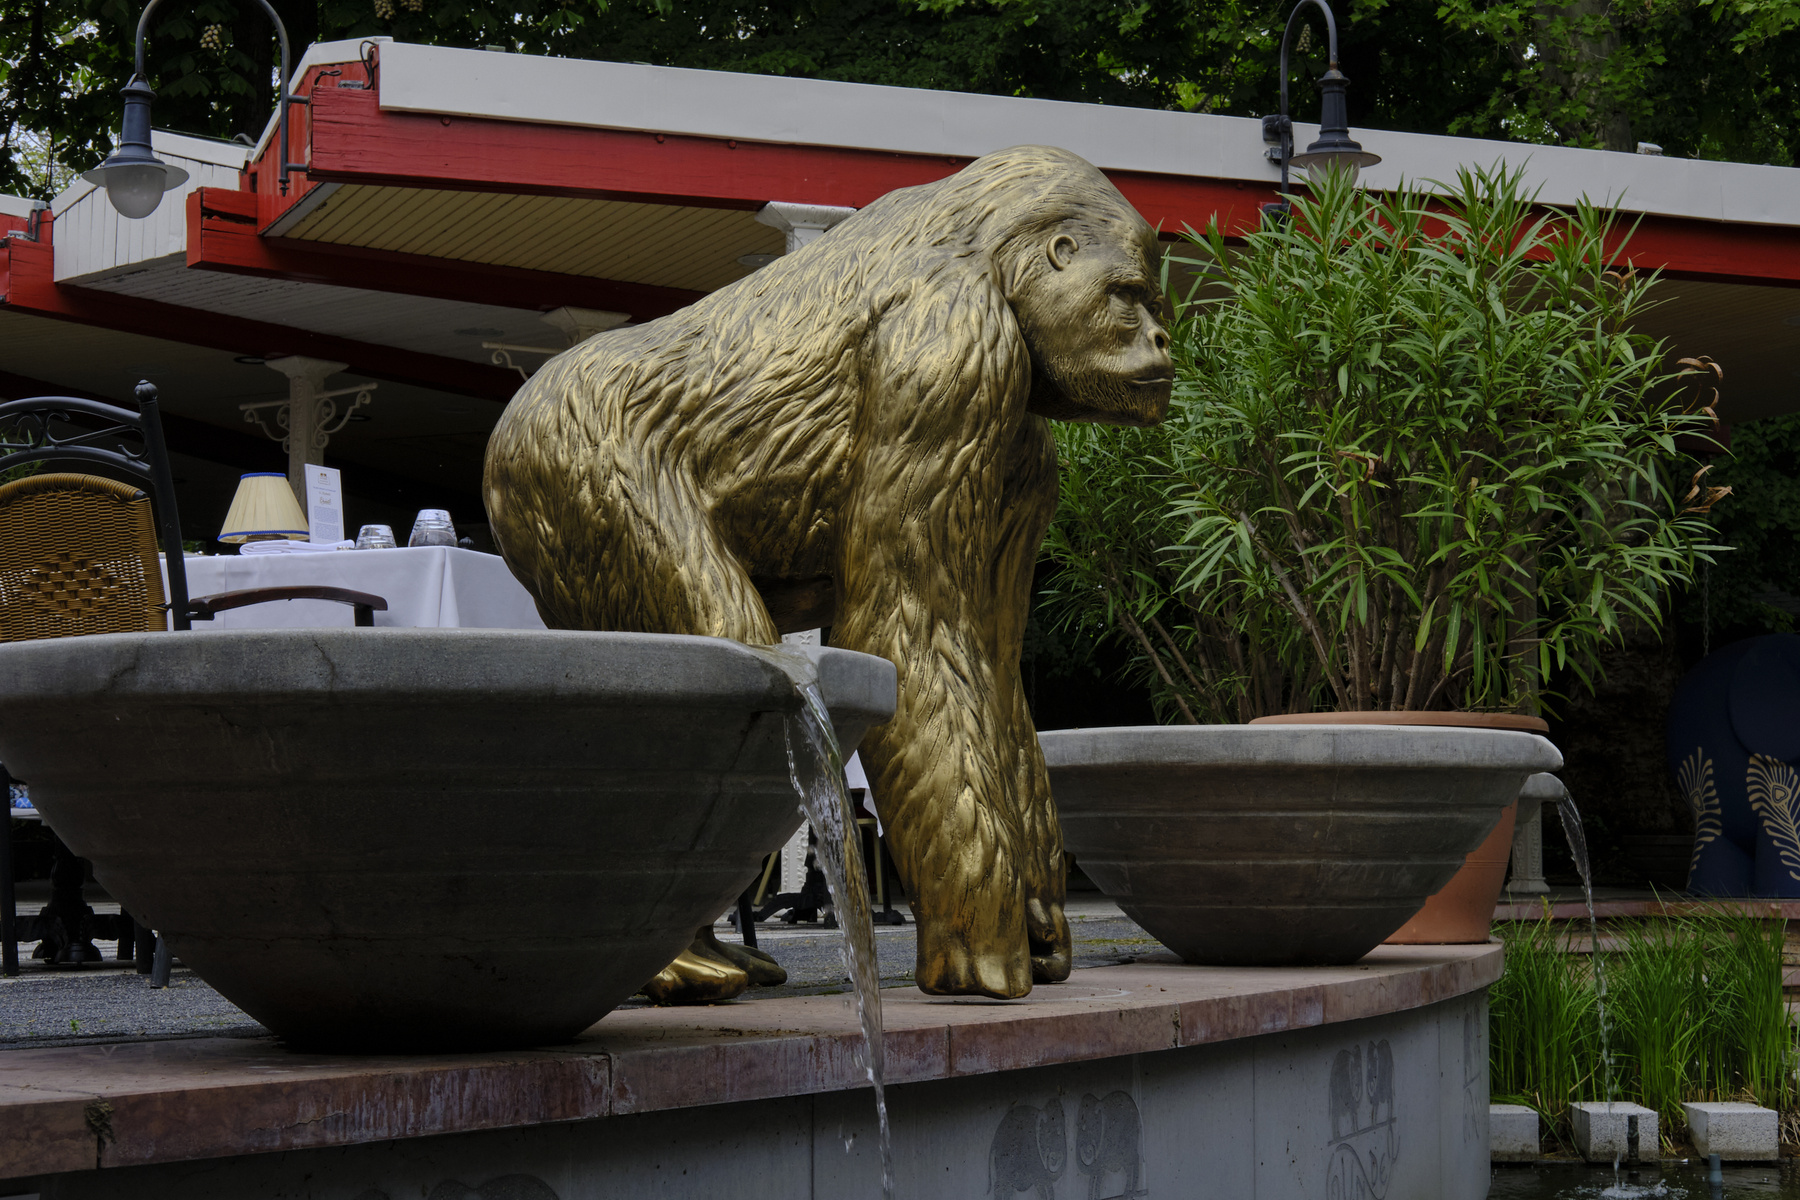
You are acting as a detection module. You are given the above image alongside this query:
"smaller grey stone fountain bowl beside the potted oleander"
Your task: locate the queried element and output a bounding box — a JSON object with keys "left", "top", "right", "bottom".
{"left": 1039, "top": 725, "right": 1562, "bottom": 966}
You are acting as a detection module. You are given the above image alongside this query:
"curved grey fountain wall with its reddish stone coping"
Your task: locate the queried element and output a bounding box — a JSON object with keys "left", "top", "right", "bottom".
{"left": 10, "top": 945, "right": 1501, "bottom": 1200}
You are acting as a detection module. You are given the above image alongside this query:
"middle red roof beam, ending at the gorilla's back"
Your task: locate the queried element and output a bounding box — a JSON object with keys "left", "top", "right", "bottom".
{"left": 187, "top": 187, "right": 706, "bottom": 316}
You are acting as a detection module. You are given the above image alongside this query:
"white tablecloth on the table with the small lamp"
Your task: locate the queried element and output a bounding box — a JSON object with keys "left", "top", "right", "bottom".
{"left": 169, "top": 545, "right": 544, "bottom": 631}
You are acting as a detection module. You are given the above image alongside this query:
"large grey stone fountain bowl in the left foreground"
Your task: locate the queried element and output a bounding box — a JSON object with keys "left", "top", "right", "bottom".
{"left": 0, "top": 630, "right": 895, "bottom": 1051}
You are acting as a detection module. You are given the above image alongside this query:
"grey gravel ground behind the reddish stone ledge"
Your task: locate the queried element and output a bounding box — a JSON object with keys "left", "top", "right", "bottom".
{"left": 0, "top": 896, "right": 1161, "bottom": 1049}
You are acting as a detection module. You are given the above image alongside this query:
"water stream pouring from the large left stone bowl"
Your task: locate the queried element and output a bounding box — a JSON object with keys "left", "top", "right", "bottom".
{"left": 776, "top": 651, "right": 895, "bottom": 1200}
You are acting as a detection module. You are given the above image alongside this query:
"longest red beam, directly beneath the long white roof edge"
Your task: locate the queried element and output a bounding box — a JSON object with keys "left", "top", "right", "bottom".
{"left": 280, "top": 88, "right": 1800, "bottom": 286}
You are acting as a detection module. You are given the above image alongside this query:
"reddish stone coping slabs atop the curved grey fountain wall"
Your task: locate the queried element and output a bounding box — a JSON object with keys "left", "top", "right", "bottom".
{"left": 0, "top": 945, "right": 1504, "bottom": 1178}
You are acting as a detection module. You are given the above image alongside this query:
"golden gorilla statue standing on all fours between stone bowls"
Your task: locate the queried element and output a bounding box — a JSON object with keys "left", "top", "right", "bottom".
{"left": 484, "top": 146, "right": 1172, "bottom": 997}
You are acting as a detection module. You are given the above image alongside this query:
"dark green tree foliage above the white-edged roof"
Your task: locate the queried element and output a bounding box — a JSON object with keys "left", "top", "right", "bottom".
{"left": 0, "top": 0, "right": 1800, "bottom": 196}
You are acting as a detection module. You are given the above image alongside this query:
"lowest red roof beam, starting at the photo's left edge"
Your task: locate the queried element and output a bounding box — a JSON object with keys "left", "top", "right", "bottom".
{"left": 0, "top": 237, "right": 520, "bottom": 403}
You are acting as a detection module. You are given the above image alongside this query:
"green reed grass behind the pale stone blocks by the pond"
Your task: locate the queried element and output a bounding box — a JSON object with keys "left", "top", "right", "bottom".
{"left": 1489, "top": 914, "right": 1800, "bottom": 1137}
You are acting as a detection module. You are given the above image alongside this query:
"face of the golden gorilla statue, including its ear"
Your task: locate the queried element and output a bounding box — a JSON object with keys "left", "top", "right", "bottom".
{"left": 1010, "top": 227, "right": 1174, "bottom": 425}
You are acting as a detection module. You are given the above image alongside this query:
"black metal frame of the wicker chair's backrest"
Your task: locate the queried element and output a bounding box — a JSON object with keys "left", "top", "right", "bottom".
{"left": 0, "top": 381, "right": 189, "bottom": 629}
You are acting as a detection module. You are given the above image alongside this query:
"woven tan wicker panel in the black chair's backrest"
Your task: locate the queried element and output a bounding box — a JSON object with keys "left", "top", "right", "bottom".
{"left": 0, "top": 475, "right": 167, "bottom": 642}
